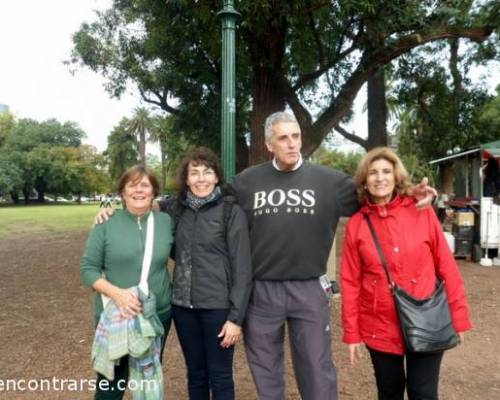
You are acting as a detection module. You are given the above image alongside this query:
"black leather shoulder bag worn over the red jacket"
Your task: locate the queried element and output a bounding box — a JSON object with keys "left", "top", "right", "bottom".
{"left": 365, "top": 214, "right": 459, "bottom": 353}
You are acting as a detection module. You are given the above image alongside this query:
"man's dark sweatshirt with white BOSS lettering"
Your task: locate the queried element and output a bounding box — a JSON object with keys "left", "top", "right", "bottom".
{"left": 233, "top": 162, "right": 359, "bottom": 281}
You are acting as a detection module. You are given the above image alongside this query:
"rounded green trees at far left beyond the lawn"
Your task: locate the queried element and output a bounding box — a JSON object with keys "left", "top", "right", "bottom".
{"left": 0, "top": 119, "right": 109, "bottom": 202}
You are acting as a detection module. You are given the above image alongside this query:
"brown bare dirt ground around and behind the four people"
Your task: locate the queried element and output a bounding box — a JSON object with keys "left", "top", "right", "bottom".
{"left": 0, "top": 223, "right": 500, "bottom": 400}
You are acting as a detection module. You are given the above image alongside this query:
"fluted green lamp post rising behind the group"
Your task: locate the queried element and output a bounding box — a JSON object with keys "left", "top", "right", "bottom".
{"left": 218, "top": 0, "right": 240, "bottom": 181}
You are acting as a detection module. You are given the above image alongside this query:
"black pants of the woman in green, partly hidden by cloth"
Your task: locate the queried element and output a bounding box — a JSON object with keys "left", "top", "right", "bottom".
{"left": 94, "top": 316, "right": 172, "bottom": 400}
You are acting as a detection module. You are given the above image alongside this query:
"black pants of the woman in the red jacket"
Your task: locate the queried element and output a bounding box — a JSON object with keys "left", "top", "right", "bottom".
{"left": 368, "top": 348, "right": 443, "bottom": 400}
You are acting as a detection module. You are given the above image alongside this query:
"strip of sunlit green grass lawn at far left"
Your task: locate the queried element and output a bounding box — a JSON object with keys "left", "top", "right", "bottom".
{"left": 0, "top": 203, "right": 111, "bottom": 237}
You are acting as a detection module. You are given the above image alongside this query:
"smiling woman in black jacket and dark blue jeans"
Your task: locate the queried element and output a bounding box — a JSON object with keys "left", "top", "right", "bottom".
{"left": 160, "top": 147, "right": 252, "bottom": 400}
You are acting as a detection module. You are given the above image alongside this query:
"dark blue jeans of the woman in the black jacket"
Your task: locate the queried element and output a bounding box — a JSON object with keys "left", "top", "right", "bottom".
{"left": 172, "top": 306, "right": 234, "bottom": 400}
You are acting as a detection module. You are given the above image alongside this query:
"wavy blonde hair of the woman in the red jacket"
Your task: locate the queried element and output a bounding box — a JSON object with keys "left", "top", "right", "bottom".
{"left": 354, "top": 147, "right": 412, "bottom": 204}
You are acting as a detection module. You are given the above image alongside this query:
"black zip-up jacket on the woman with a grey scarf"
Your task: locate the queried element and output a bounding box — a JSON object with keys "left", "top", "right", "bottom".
{"left": 160, "top": 191, "right": 252, "bottom": 325}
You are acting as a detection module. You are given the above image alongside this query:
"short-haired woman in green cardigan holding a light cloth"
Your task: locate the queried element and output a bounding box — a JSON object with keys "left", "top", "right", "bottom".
{"left": 80, "top": 165, "right": 174, "bottom": 399}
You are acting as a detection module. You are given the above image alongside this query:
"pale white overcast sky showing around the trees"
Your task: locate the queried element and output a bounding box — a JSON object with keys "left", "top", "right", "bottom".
{"left": 0, "top": 0, "right": 500, "bottom": 153}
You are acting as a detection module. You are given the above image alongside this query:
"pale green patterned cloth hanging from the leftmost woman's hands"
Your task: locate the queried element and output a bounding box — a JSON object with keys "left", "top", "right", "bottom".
{"left": 92, "top": 287, "right": 164, "bottom": 400}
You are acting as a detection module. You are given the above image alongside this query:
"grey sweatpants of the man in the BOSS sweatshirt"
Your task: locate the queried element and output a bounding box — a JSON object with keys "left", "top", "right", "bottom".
{"left": 244, "top": 279, "right": 338, "bottom": 400}
